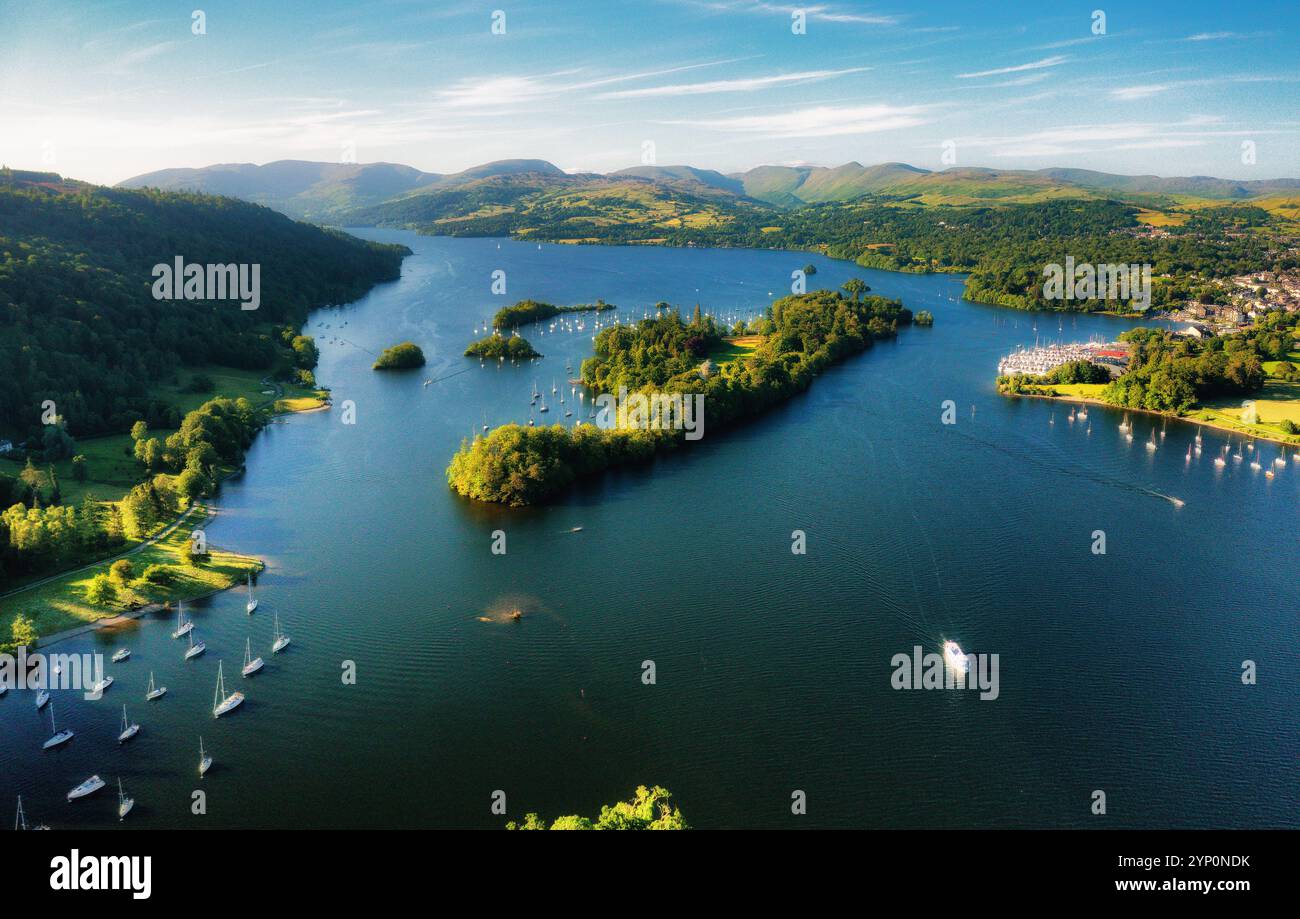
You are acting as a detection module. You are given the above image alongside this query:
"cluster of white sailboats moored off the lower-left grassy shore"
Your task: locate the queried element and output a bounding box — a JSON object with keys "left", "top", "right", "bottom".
{"left": 14, "top": 575, "right": 290, "bottom": 829}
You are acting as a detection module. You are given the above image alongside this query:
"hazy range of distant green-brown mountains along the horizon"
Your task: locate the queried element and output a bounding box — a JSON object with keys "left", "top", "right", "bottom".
{"left": 121, "top": 154, "right": 1300, "bottom": 226}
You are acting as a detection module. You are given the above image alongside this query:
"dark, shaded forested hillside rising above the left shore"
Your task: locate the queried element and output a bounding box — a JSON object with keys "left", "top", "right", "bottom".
{"left": 0, "top": 170, "right": 406, "bottom": 442}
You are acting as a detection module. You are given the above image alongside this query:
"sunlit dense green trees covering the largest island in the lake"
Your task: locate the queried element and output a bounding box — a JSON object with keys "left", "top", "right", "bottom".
{"left": 447, "top": 282, "right": 913, "bottom": 506}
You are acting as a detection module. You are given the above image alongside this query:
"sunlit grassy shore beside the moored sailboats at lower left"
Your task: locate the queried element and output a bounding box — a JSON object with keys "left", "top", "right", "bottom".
{"left": 0, "top": 504, "right": 261, "bottom": 647}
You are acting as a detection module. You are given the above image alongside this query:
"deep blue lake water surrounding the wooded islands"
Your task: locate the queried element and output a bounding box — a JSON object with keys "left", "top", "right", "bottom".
{"left": 0, "top": 230, "right": 1300, "bottom": 828}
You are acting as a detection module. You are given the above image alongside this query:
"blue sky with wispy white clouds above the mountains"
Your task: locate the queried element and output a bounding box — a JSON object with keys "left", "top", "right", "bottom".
{"left": 0, "top": 0, "right": 1300, "bottom": 183}
